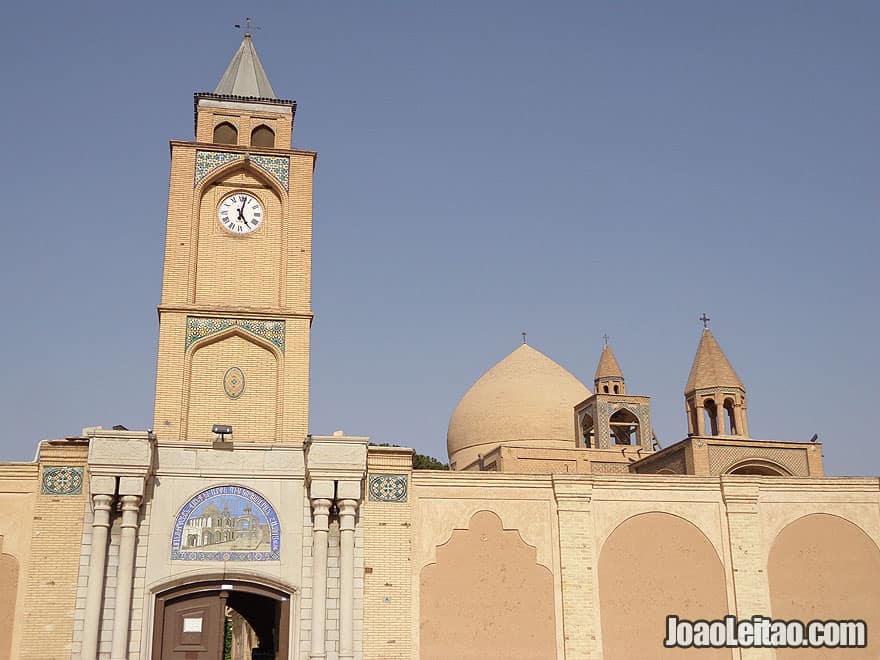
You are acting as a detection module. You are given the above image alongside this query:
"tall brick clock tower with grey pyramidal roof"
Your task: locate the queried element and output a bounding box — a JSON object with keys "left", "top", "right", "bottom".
{"left": 154, "top": 35, "right": 317, "bottom": 444}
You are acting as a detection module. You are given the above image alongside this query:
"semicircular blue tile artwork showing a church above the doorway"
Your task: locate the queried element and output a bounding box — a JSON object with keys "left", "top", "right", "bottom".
{"left": 171, "top": 486, "right": 281, "bottom": 561}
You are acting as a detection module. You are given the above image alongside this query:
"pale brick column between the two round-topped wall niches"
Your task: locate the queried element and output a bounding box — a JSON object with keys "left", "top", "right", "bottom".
{"left": 721, "top": 476, "right": 776, "bottom": 660}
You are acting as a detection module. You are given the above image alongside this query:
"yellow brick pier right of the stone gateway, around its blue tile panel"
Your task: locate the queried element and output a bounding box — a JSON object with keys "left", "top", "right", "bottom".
{"left": 361, "top": 447, "right": 418, "bottom": 660}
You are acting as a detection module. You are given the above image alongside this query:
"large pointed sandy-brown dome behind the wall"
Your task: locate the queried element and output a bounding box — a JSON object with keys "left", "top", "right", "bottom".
{"left": 446, "top": 344, "right": 591, "bottom": 469}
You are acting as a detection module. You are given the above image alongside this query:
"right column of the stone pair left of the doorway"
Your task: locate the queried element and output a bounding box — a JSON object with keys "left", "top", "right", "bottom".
{"left": 110, "top": 477, "right": 144, "bottom": 660}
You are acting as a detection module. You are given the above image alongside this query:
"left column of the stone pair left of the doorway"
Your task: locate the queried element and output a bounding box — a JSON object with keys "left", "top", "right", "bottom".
{"left": 82, "top": 477, "right": 116, "bottom": 660}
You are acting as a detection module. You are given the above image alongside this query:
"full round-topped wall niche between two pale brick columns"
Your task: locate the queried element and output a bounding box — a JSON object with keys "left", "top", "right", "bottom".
{"left": 596, "top": 512, "right": 732, "bottom": 660}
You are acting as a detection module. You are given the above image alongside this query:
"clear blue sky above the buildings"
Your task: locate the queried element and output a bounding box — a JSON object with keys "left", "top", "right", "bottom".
{"left": 0, "top": 0, "right": 880, "bottom": 475}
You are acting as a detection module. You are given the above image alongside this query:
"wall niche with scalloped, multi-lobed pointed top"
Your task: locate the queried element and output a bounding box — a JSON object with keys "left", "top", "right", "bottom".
{"left": 419, "top": 511, "right": 556, "bottom": 660}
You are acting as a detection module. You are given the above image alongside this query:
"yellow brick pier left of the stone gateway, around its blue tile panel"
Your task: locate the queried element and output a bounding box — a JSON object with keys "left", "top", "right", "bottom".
{"left": 19, "top": 440, "right": 88, "bottom": 660}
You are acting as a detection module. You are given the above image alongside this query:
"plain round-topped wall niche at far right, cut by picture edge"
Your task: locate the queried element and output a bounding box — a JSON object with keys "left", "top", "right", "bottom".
{"left": 767, "top": 513, "right": 880, "bottom": 660}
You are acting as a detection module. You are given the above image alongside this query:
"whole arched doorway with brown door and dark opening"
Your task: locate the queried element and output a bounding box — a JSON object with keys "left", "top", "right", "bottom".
{"left": 152, "top": 579, "right": 291, "bottom": 660}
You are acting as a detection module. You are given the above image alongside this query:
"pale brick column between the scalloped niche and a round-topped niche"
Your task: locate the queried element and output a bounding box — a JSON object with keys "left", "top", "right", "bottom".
{"left": 553, "top": 475, "right": 599, "bottom": 660}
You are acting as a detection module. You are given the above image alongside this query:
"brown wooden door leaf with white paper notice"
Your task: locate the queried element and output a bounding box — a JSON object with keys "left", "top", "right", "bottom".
{"left": 160, "top": 592, "right": 226, "bottom": 660}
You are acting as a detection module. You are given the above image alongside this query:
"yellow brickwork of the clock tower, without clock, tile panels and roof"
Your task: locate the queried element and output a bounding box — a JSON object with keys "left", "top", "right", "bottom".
{"left": 154, "top": 119, "right": 316, "bottom": 443}
